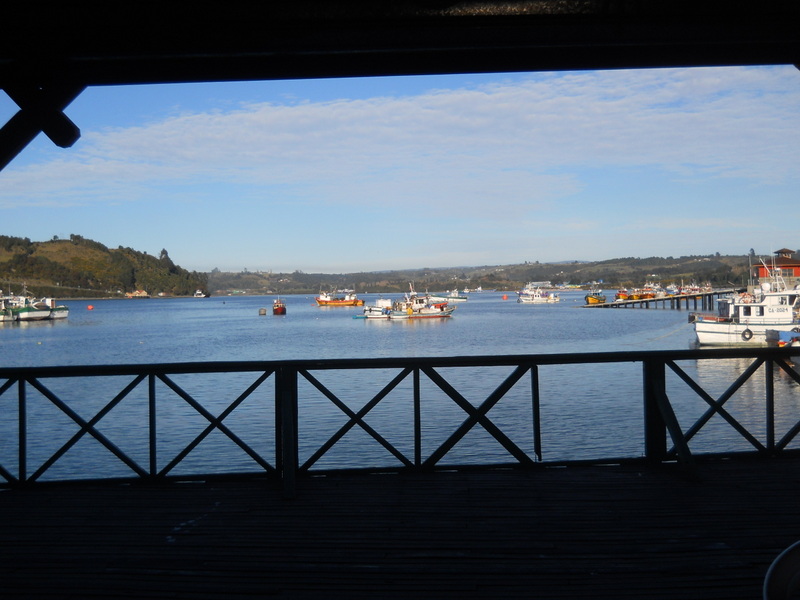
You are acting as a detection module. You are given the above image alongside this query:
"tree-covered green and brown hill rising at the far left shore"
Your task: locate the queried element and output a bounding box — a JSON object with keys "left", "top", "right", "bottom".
{"left": 0, "top": 235, "right": 208, "bottom": 298}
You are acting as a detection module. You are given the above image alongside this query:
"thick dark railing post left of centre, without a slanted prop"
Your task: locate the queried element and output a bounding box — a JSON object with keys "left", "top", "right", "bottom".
{"left": 275, "top": 365, "right": 299, "bottom": 498}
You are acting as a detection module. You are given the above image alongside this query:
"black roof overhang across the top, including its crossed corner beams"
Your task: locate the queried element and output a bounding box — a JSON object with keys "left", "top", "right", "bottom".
{"left": 0, "top": 0, "right": 800, "bottom": 168}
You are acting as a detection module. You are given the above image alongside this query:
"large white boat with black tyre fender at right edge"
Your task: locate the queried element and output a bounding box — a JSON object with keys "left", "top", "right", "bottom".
{"left": 689, "top": 271, "right": 800, "bottom": 346}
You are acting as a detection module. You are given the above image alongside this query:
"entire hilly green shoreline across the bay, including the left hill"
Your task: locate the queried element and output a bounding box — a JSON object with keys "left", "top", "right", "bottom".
{"left": 0, "top": 235, "right": 757, "bottom": 298}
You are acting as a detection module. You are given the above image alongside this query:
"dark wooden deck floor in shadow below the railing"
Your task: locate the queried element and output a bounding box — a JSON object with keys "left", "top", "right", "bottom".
{"left": 0, "top": 459, "right": 800, "bottom": 600}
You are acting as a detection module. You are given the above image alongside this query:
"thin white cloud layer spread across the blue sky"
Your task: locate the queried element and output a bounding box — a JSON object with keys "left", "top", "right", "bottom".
{"left": 0, "top": 67, "right": 800, "bottom": 268}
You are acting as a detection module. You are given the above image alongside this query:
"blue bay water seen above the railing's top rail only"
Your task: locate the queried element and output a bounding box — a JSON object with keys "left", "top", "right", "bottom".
{"left": 0, "top": 292, "right": 693, "bottom": 366}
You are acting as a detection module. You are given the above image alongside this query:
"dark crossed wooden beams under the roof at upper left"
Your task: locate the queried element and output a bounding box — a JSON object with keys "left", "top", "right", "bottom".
{"left": 0, "top": 84, "right": 85, "bottom": 170}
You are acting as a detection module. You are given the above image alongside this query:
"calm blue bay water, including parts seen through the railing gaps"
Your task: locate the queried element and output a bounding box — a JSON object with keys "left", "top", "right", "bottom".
{"left": 0, "top": 292, "right": 800, "bottom": 479}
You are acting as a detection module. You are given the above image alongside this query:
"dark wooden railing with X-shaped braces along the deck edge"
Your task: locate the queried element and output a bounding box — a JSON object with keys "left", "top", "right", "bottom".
{"left": 0, "top": 348, "right": 800, "bottom": 494}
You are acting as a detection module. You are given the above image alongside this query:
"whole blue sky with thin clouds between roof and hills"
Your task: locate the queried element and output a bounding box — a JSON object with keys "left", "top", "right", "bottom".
{"left": 0, "top": 66, "right": 800, "bottom": 273}
